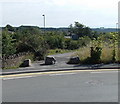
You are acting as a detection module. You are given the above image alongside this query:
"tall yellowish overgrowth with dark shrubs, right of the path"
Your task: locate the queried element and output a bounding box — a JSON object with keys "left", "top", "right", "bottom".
{"left": 75, "top": 33, "right": 120, "bottom": 64}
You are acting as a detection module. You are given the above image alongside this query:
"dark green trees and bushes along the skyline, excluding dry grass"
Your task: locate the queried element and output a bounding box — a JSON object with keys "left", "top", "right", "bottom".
{"left": 2, "top": 22, "right": 119, "bottom": 60}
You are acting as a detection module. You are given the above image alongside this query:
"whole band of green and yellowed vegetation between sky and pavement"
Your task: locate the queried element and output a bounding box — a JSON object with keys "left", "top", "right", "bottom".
{"left": 2, "top": 22, "right": 120, "bottom": 68}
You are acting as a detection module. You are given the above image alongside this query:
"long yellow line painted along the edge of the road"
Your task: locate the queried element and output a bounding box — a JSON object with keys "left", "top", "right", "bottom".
{"left": 0, "top": 69, "right": 119, "bottom": 78}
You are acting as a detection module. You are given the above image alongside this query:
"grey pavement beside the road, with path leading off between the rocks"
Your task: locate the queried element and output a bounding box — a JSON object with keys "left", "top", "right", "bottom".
{"left": 2, "top": 52, "right": 120, "bottom": 75}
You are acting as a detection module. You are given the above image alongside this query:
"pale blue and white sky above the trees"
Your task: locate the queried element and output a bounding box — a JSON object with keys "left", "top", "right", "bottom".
{"left": 0, "top": 0, "right": 119, "bottom": 28}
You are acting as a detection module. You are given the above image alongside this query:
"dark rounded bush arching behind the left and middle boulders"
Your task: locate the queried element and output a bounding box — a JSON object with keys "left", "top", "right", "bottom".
{"left": 17, "top": 35, "right": 48, "bottom": 60}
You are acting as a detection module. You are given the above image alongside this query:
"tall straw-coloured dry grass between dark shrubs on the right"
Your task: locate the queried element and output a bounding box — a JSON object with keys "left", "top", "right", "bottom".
{"left": 73, "top": 47, "right": 120, "bottom": 64}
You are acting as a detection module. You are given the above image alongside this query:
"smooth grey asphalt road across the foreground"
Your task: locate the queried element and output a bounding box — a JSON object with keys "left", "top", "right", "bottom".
{"left": 2, "top": 70, "right": 118, "bottom": 102}
